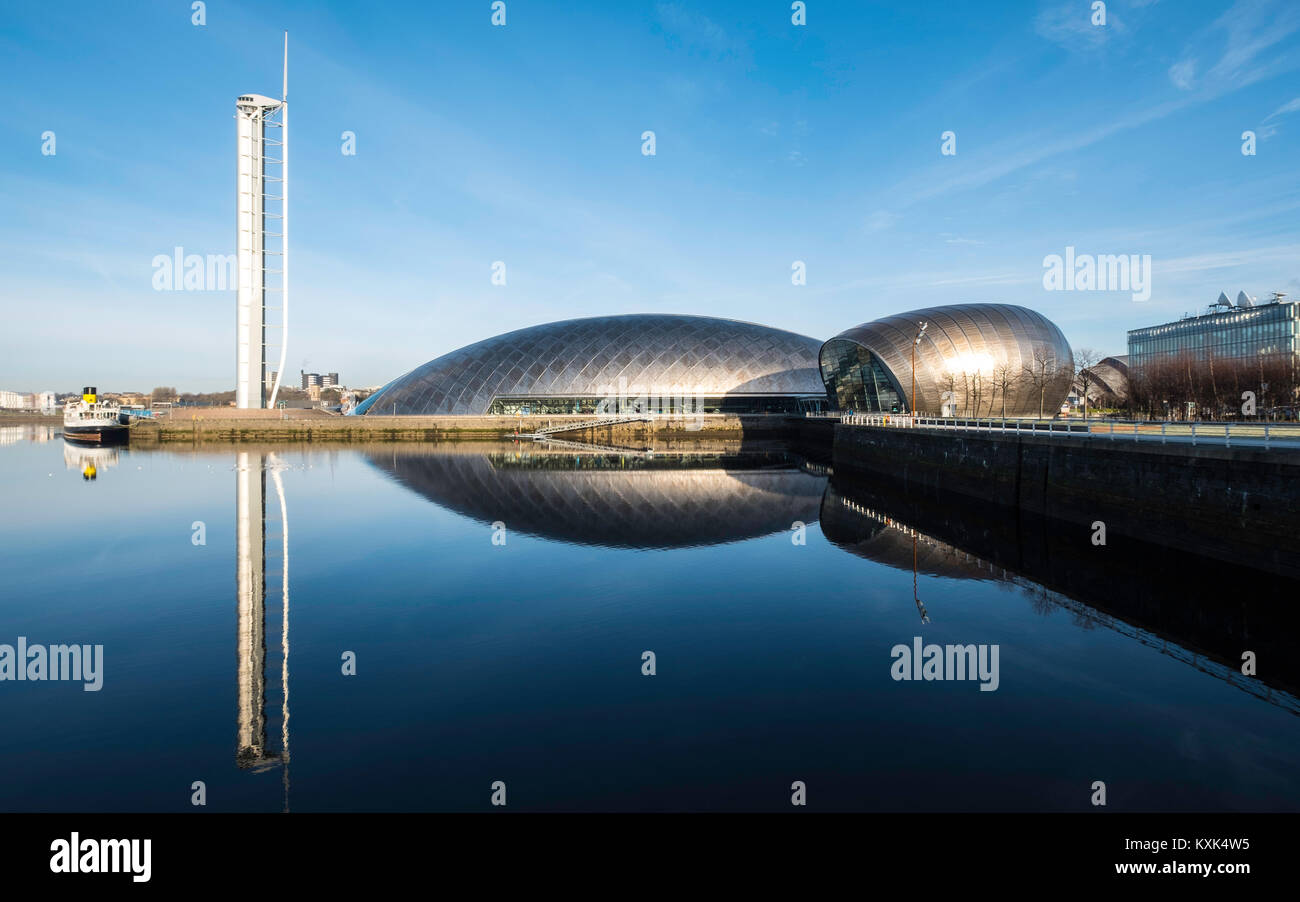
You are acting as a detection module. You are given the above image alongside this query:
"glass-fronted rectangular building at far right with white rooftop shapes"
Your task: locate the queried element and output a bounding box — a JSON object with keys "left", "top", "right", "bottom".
{"left": 1128, "top": 291, "right": 1300, "bottom": 370}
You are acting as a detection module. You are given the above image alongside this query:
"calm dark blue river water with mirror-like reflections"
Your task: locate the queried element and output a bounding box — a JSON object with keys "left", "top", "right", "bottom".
{"left": 0, "top": 426, "right": 1300, "bottom": 811}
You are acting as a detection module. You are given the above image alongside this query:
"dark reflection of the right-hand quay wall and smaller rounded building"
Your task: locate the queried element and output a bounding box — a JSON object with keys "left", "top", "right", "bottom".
{"left": 820, "top": 478, "right": 1300, "bottom": 715}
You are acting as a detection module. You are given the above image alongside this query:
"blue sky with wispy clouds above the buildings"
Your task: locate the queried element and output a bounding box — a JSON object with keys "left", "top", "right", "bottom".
{"left": 0, "top": 0, "right": 1300, "bottom": 391}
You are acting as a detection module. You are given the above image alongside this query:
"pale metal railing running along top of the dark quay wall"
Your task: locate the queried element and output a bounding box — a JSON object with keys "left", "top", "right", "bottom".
{"left": 840, "top": 413, "right": 1300, "bottom": 448}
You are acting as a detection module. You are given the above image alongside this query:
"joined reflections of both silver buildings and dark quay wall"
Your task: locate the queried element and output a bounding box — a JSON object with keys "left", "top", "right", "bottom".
{"left": 368, "top": 446, "right": 1300, "bottom": 714}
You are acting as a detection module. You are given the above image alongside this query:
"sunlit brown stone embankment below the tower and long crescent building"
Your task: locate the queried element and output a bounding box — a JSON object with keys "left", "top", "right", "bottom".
{"left": 131, "top": 408, "right": 796, "bottom": 446}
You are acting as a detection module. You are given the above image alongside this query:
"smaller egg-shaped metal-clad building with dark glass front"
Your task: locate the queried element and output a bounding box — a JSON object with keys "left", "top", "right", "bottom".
{"left": 819, "top": 304, "right": 1074, "bottom": 416}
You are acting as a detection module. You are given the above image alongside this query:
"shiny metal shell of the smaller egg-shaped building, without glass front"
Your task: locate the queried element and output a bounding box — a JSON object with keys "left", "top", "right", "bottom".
{"left": 819, "top": 304, "right": 1074, "bottom": 416}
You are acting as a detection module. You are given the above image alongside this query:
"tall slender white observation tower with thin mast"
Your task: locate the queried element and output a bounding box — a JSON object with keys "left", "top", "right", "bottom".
{"left": 235, "top": 31, "right": 289, "bottom": 409}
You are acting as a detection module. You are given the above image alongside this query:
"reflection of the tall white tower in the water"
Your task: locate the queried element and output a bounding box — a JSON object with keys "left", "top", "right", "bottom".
{"left": 235, "top": 451, "right": 289, "bottom": 811}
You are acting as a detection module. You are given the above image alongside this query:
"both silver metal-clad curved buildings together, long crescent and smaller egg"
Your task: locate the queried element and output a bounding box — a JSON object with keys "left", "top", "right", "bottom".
{"left": 354, "top": 304, "right": 1074, "bottom": 416}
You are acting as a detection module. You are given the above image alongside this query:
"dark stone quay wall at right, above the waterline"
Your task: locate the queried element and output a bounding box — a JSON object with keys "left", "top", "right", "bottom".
{"left": 832, "top": 425, "right": 1300, "bottom": 576}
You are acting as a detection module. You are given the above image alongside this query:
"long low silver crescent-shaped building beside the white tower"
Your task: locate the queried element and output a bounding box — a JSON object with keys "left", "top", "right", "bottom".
{"left": 355, "top": 315, "right": 826, "bottom": 416}
